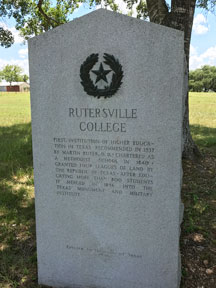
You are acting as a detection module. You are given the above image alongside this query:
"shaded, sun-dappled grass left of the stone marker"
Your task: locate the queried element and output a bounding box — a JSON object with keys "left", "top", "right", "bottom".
{"left": 0, "top": 123, "right": 39, "bottom": 287}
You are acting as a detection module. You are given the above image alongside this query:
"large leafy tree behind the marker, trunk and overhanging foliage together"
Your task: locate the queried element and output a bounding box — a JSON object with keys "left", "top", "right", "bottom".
{"left": 0, "top": 0, "right": 216, "bottom": 157}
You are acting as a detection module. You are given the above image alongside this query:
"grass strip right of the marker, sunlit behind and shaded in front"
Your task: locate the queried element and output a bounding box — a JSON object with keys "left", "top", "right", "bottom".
{"left": 181, "top": 93, "right": 216, "bottom": 288}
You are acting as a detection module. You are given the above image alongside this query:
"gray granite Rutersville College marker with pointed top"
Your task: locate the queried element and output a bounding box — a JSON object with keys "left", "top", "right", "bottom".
{"left": 29, "top": 9, "right": 184, "bottom": 288}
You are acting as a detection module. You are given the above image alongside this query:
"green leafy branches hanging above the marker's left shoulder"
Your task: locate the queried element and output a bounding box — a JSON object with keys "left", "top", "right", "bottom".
{"left": 0, "top": 0, "right": 84, "bottom": 47}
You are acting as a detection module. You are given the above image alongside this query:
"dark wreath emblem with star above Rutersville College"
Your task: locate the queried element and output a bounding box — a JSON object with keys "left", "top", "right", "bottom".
{"left": 80, "top": 53, "right": 123, "bottom": 98}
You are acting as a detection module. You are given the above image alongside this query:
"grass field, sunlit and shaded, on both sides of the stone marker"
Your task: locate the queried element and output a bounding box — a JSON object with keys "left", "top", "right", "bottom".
{"left": 0, "top": 92, "right": 216, "bottom": 288}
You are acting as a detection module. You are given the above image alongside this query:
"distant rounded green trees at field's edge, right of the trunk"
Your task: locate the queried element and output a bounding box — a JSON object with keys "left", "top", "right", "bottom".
{"left": 189, "top": 65, "right": 216, "bottom": 92}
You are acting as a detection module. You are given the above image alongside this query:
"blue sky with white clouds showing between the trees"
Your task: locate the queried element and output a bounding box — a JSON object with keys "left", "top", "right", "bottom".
{"left": 0, "top": 1, "right": 216, "bottom": 75}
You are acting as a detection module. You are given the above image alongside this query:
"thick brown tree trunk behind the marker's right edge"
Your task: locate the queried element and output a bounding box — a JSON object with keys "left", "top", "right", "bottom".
{"left": 146, "top": 0, "right": 200, "bottom": 158}
